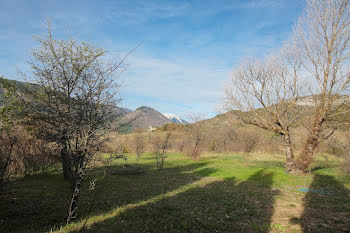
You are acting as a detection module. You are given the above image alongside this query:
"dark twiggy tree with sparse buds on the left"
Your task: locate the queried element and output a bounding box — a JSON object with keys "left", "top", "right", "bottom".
{"left": 21, "top": 22, "right": 131, "bottom": 222}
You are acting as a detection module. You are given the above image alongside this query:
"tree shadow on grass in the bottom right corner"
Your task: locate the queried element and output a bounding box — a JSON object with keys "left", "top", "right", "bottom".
{"left": 291, "top": 174, "right": 350, "bottom": 233}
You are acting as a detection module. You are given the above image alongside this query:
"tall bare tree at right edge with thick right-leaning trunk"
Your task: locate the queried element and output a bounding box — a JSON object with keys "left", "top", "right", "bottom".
{"left": 293, "top": 0, "right": 350, "bottom": 172}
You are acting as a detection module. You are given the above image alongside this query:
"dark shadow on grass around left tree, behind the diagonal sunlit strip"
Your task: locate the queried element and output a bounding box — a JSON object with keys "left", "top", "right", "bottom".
{"left": 0, "top": 160, "right": 214, "bottom": 232}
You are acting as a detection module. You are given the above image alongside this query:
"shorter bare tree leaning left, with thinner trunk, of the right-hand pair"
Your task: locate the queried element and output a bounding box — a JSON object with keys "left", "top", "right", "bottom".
{"left": 225, "top": 51, "right": 301, "bottom": 172}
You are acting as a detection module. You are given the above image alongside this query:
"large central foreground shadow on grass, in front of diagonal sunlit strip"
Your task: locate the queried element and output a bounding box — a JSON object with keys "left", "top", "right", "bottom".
{"left": 71, "top": 170, "right": 278, "bottom": 232}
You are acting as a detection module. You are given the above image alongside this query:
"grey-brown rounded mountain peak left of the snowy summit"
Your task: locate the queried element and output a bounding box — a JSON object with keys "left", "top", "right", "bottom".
{"left": 122, "top": 106, "right": 172, "bottom": 132}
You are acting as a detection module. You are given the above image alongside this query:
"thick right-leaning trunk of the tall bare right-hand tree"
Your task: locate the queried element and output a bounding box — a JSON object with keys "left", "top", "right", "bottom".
{"left": 296, "top": 117, "right": 324, "bottom": 173}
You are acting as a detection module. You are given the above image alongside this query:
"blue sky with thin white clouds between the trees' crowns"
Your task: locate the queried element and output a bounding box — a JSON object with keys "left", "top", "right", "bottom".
{"left": 0, "top": 0, "right": 305, "bottom": 118}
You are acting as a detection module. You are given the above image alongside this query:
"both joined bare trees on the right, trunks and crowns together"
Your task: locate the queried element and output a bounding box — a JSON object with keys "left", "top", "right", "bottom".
{"left": 226, "top": 0, "right": 350, "bottom": 173}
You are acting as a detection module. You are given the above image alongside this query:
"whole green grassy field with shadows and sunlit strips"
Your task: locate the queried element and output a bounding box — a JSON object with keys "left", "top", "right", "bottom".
{"left": 0, "top": 154, "right": 350, "bottom": 232}
